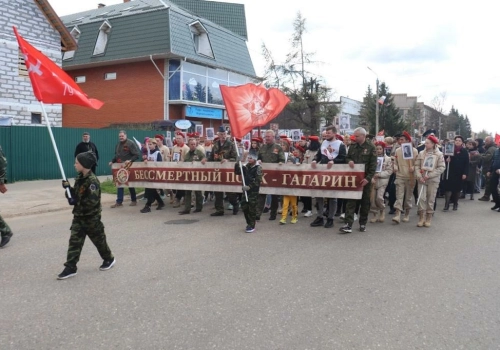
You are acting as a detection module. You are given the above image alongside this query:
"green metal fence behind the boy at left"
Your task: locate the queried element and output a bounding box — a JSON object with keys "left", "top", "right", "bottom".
{"left": 0, "top": 126, "right": 158, "bottom": 182}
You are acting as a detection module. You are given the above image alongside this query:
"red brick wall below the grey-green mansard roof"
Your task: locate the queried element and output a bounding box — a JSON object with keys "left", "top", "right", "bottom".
{"left": 63, "top": 60, "right": 166, "bottom": 128}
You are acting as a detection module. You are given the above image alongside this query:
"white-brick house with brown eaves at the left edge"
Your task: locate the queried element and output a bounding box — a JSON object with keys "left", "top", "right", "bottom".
{"left": 0, "top": 0, "right": 76, "bottom": 126}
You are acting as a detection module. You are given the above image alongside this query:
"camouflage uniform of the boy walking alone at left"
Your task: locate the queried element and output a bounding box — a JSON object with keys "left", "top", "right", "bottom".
{"left": 64, "top": 172, "right": 113, "bottom": 271}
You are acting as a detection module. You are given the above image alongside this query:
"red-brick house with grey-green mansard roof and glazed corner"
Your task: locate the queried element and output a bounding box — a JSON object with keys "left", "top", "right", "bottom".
{"left": 62, "top": 0, "right": 259, "bottom": 128}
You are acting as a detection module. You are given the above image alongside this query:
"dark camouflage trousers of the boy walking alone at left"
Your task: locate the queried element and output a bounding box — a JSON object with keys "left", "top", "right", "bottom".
{"left": 64, "top": 215, "right": 113, "bottom": 271}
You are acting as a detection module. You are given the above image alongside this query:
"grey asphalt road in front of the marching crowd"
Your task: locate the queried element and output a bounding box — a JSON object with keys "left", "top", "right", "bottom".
{"left": 0, "top": 196, "right": 500, "bottom": 350}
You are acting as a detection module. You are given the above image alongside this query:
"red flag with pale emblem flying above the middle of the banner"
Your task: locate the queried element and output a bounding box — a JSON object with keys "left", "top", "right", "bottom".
{"left": 220, "top": 83, "right": 290, "bottom": 137}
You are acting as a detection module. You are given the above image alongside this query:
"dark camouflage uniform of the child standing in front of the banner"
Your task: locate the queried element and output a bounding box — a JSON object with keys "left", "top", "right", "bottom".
{"left": 234, "top": 163, "right": 262, "bottom": 228}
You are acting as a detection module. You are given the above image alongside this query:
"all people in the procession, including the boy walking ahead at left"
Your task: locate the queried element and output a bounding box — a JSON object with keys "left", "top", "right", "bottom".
{"left": 0, "top": 126, "right": 500, "bottom": 279}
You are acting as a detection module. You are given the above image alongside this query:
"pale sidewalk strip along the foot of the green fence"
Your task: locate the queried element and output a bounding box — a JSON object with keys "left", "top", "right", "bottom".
{"left": 0, "top": 175, "right": 138, "bottom": 218}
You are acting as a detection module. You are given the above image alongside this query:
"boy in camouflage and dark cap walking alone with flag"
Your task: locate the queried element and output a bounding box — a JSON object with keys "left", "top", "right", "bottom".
{"left": 57, "top": 152, "right": 115, "bottom": 280}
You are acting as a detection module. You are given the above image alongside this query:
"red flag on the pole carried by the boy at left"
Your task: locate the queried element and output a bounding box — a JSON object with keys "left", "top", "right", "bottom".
{"left": 13, "top": 27, "right": 104, "bottom": 109}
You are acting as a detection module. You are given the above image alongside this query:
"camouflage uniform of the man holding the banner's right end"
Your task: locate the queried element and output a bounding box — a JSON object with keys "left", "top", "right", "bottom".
{"left": 345, "top": 141, "right": 377, "bottom": 226}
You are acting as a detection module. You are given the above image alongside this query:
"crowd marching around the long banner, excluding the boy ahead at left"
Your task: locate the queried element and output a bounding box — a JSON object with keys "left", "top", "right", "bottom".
{"left": 105, "top": 126, "right": 500, "bottom": 233}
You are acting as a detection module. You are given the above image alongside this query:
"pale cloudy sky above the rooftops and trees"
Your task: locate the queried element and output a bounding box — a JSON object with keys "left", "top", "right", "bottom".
{"left": 50, "top": 0, "right": 500, "bottom": 134}
